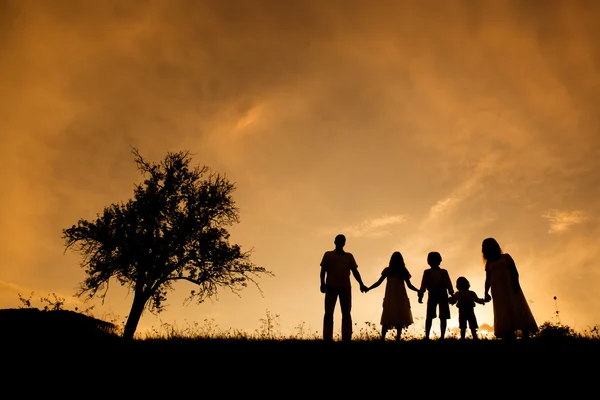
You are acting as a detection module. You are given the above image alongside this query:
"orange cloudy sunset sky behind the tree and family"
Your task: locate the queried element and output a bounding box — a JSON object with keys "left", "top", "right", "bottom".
{"left": 0, "top": 0, "right": 600, "bottom": 335}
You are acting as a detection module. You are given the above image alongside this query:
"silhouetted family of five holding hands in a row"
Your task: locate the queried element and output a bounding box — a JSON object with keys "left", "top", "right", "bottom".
{"left": 320, "top": 234, "right": 539, "bottom": 342}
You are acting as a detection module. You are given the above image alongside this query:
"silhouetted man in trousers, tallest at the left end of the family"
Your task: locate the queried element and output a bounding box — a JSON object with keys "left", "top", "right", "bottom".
{"left": 320, "top": 234, "right": 367, "bottom": 342}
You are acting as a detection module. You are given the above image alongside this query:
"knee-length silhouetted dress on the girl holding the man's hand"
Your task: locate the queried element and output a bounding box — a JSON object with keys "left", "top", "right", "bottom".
{"left": 381, "top": 267, "right": 413, "bottom": 327}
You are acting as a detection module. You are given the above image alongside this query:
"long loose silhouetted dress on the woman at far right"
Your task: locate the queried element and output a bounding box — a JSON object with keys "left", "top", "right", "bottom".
{"left": 485, "top": 254, "right": 538, "bottom": 337}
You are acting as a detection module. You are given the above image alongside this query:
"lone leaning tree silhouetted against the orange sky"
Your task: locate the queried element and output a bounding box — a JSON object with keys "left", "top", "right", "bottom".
{"left": 62, "top": 148, "right": 273, "bottom": 339}
